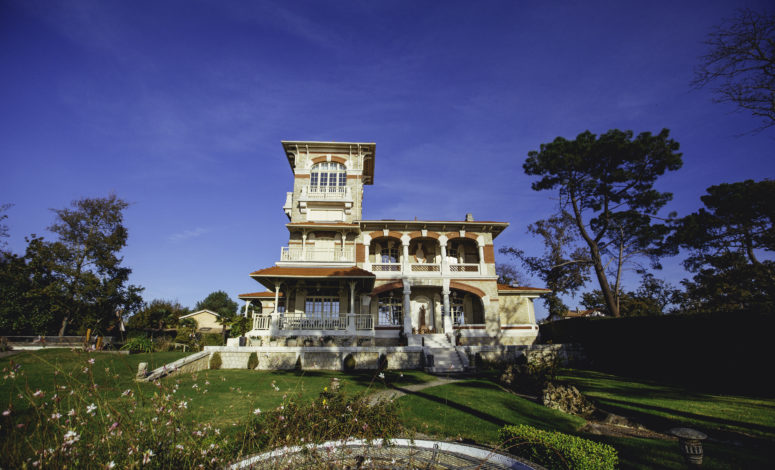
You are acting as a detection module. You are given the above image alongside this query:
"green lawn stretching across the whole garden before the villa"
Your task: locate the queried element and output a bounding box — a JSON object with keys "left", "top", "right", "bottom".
{"left": 0, "top": 349, "right": 775, "bottom": 469}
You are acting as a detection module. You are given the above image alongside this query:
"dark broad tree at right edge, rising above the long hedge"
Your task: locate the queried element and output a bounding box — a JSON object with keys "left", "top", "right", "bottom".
{"left": 669, "top": 180, "right": 775, "bottom": 311}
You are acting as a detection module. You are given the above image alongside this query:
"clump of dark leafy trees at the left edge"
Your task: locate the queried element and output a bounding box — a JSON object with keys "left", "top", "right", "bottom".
{"left": 0, "top": 195, "right": 142, "bottom": 335}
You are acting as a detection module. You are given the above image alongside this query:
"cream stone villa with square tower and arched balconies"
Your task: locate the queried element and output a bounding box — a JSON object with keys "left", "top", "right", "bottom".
{"left": 238, "top": 141, "right": 549, "bottom": 346}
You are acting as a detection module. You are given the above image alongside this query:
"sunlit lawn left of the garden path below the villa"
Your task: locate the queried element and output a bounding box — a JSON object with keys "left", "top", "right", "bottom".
{"left": 0, "top": 349, "right": 435, "bottom": 426}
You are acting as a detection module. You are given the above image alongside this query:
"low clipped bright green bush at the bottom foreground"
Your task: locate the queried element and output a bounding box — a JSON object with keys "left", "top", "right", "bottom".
{"left": 498, "top": 424, "right": 619, "bottom": 470}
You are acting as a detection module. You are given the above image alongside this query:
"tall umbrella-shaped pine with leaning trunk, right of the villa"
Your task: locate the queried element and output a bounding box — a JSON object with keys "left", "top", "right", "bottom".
{"left": 523, "top": 129, "right": 682, "bottom": 316}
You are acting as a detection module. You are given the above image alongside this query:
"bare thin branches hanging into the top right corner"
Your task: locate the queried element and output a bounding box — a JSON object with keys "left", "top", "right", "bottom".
{"left": 692, "top": 9, "right": 775, "bottom": 128}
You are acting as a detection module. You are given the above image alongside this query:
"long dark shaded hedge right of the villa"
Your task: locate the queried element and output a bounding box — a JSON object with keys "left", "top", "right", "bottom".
{"left": 540, "top": 312, "right": 775, "bottom": 389}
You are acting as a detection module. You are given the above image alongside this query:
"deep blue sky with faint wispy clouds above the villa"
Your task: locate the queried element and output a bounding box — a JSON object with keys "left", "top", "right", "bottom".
{"left": 0, "top": 0, "right": 775, "bottom": 320}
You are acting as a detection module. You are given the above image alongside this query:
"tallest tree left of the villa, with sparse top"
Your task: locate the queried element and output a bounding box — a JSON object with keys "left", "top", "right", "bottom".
{"left": 49, "top": 194, "right": 142, "bottom": 336}
